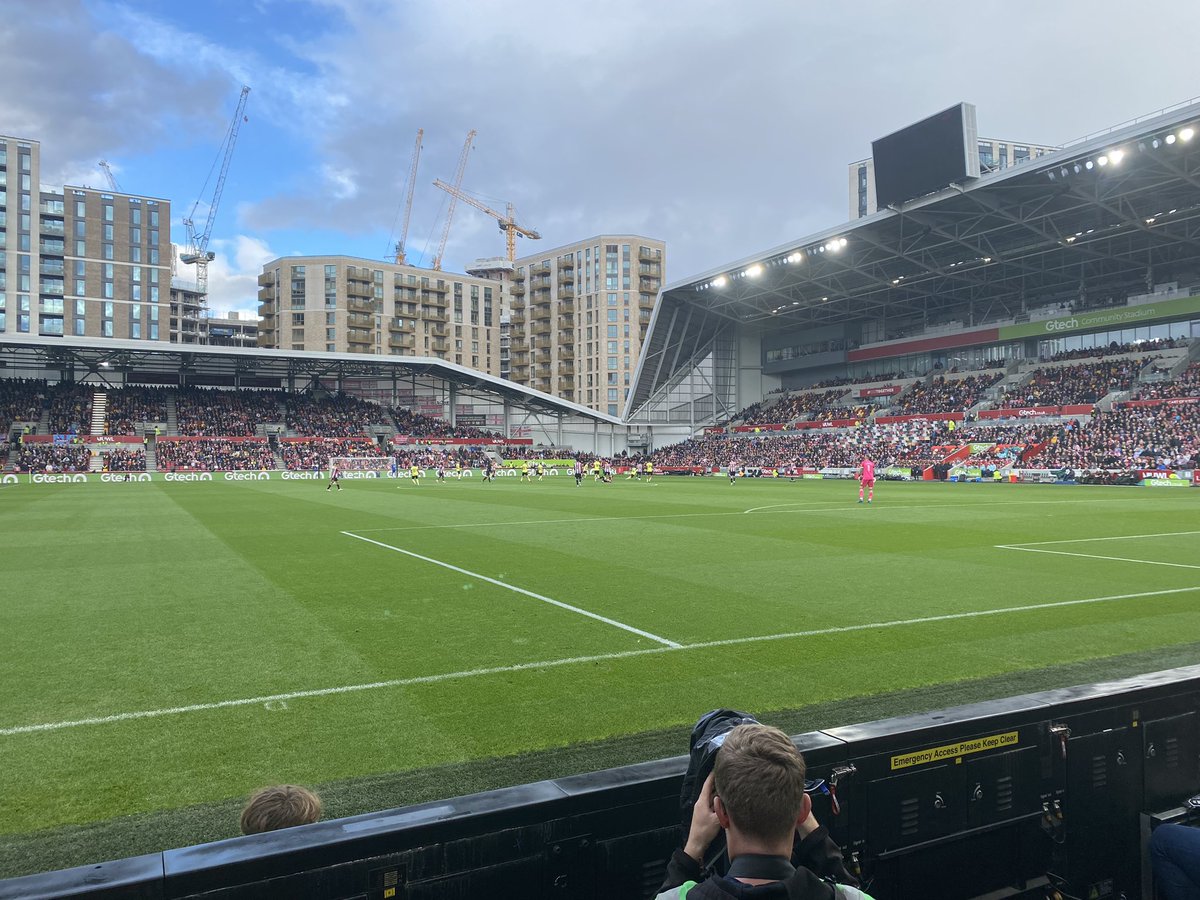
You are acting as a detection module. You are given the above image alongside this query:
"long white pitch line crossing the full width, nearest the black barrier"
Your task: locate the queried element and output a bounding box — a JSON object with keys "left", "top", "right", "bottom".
{"left": 0, "top": 586, "right": 1200, "bottom": 737}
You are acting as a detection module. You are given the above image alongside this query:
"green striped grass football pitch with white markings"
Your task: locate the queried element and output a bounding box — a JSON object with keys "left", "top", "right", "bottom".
{"left": 0, "top": 475, "right": 1200, "bottom": 875}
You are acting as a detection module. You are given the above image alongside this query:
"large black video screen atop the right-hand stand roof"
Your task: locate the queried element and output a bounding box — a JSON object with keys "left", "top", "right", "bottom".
{"left": 871, "top": 103, "right": 979, "bottom": 209}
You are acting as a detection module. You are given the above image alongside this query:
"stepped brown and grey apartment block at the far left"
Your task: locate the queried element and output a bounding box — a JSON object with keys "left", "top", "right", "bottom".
{"left": 0, "top": 136, "right": 170, "bottom": 341}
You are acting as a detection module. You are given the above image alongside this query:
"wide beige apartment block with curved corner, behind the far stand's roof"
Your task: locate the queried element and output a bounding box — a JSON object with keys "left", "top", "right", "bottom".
{"left": 258, "top": 256, "right": 504, "bottom": 376}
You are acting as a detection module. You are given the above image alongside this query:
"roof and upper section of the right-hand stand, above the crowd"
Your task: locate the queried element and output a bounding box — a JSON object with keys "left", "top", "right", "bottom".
{"left": 625, "top": 102, "right": 1200, "bottom": 430}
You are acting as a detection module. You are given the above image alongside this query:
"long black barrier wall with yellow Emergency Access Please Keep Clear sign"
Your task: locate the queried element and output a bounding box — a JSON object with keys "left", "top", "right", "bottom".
{"left": 0, "top": 666, "right": 1200, "bottom": 900}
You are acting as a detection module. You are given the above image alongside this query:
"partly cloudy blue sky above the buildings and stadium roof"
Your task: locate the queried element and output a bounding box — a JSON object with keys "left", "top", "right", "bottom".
{"left": 7, "top": 0, "right": 1200, "bottom": 311}
